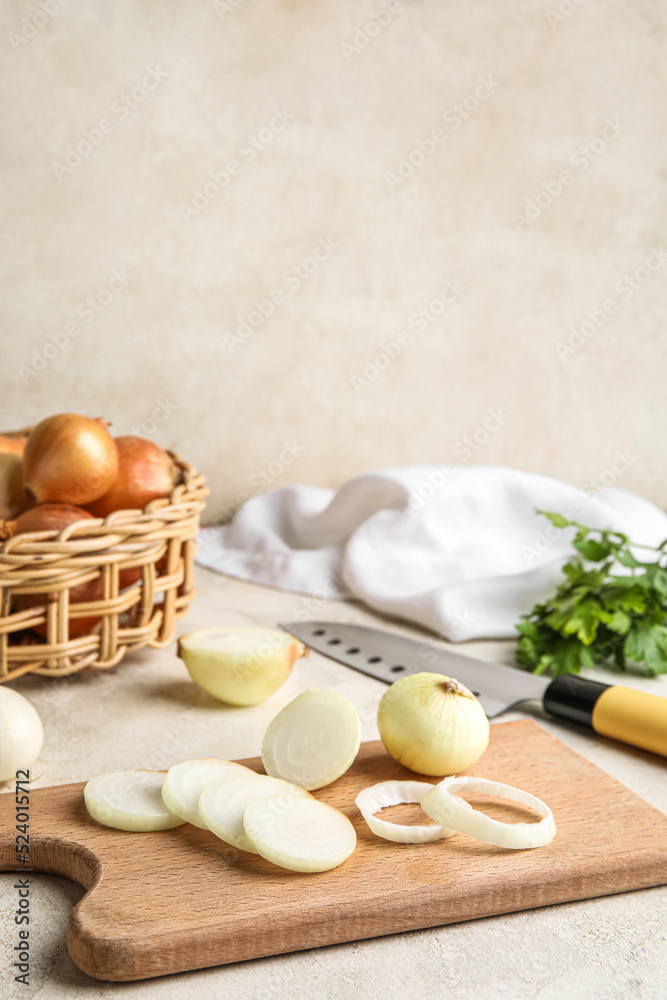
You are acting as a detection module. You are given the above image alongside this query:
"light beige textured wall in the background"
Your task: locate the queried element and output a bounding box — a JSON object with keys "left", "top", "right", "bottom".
{"left": 0, "top": 0, "right": 667, "bottom": 518}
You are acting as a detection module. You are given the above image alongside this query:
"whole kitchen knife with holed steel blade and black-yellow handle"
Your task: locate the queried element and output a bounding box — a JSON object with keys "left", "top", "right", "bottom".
{"left": 280, "top": 622, "right": 667, "bottom": 756}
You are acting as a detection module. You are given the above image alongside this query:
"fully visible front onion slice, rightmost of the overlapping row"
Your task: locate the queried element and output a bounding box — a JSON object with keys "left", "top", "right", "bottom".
{"left": 243, "top": 795, "right": 357, "bottom": 872}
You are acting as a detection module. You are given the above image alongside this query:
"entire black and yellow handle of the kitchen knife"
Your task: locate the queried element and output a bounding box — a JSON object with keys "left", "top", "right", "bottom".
{"left": 544, "top": 674, "right": 667, "bottom": 757}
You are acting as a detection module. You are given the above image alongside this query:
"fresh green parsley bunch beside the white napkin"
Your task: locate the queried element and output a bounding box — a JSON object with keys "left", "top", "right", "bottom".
{"left": 516, "top": 510, "right": 667, "bottom": 676}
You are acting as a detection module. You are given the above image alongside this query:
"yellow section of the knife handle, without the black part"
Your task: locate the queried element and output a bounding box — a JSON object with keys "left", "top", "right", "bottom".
{"left": 591, "top": 685, "right": 667, "bottom": 757}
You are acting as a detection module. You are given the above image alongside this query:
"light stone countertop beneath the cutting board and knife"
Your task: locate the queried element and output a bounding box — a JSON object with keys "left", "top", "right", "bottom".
{"left": 0, "top": 569, "right": 667, "bottom": 1000}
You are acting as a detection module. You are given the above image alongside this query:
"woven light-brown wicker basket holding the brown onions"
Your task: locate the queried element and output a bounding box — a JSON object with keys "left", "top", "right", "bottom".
{"left": 0, "top": 452, "right": 208, "bottom": 683}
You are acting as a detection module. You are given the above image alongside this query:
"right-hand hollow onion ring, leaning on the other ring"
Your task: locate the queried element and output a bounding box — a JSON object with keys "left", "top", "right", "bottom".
{"left": 421, "top": 776, "right": 556, "bottom": 850}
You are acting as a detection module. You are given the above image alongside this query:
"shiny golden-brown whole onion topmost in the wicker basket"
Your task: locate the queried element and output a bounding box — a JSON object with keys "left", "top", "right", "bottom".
{"left": 23, "top": 413, "right": 118, "bottom": 506}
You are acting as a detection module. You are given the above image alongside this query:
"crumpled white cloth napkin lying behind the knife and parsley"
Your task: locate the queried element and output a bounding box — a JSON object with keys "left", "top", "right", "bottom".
{"left": 197, "top": 466, "right": 667, "bottom": 642}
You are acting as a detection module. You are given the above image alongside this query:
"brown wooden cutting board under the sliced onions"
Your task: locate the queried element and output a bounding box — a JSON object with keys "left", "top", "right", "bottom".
{"left": 0, "top": 720, "right": 667, "bottom": 980}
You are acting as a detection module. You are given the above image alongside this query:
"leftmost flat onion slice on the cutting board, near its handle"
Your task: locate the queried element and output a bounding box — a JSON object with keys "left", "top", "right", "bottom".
{"left": 83, "top": 771, "right": 188, "bottom": 833}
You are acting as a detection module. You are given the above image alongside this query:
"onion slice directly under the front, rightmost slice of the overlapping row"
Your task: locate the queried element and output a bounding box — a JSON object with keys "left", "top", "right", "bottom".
{"left": 199, "top": 769, "right": 310, "bottom": 854}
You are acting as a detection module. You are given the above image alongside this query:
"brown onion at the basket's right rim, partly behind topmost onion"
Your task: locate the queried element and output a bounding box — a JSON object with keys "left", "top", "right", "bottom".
{"left": 87, "top": 435, "right": 180, "bottom": 517}
